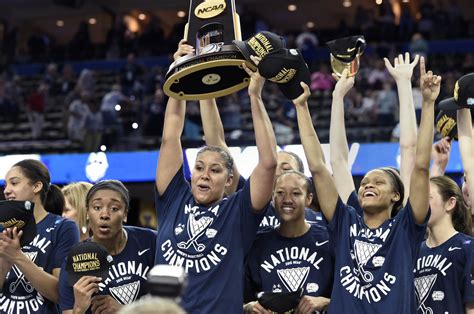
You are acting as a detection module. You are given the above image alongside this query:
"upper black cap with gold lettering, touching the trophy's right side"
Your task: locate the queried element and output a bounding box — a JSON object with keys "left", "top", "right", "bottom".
{"left": 232, "top": 31, "right": 286, "bottom": 64}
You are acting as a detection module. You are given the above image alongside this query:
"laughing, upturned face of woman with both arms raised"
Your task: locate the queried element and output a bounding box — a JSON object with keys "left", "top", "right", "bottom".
{"left": 358, "top": 169, "right": 400, "bottom": 213}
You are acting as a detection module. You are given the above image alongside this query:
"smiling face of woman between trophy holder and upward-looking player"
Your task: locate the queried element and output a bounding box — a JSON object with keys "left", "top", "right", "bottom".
{"left": 273, "top": 172, "right": 312, "bottom": 224}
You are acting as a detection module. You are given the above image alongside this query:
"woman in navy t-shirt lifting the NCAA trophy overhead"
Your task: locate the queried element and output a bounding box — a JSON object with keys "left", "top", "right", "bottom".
{"left": 156, "top": 41, "right": 277, "bottom": 313}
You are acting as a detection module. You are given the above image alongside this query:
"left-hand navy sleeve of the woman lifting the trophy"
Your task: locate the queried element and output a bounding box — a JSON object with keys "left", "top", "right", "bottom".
{"left": 155, "top": 166, "right": 191, "bottom": 221}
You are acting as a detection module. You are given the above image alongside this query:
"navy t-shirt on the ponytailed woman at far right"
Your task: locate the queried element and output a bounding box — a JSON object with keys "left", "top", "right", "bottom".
{"left": 415, "top": 233, "right": 474, "bottom": 313}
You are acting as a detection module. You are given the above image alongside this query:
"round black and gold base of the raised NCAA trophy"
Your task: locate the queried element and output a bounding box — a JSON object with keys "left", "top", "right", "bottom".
{"left": 163, "top": 45, "right": 256, "bottom": 100}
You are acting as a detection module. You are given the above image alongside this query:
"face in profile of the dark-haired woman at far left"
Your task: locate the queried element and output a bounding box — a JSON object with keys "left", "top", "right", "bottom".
{"left": 3, "top": 166, "right": 43, "bottom": 202}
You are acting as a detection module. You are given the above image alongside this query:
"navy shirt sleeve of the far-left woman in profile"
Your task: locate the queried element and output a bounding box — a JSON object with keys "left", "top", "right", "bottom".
{"left": 52, "top": 218, "right": 79, "bottom": 269}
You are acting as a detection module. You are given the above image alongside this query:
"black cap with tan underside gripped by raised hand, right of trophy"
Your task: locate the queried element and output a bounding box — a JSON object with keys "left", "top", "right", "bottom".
{"left": 326, "top": 35, "right": 366, "bottom": 76}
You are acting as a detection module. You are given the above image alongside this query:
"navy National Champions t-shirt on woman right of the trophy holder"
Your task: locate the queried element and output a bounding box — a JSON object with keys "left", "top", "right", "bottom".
{"left": 245, "top": 224, "right": 334, "bottom": 302}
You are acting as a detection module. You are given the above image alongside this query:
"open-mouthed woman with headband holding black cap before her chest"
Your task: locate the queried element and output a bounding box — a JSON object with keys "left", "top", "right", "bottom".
{"left": 59, "top": 180, "right": 156, "bottom": 314}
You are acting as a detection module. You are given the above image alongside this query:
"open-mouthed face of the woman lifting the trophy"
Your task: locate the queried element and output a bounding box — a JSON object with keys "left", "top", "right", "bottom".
{"left": 191, "top": 151, "right": 232, "bottom": 205}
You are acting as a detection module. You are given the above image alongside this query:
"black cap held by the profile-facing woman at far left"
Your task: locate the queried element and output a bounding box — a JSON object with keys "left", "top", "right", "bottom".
{"left": 0, "top": 201, "right": 36, "bottom": 246}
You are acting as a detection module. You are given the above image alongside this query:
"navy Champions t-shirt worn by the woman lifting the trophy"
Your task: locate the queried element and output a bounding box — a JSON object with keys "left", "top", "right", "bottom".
{"left": 155, "top": 168, "right": 265, "bottom": 313}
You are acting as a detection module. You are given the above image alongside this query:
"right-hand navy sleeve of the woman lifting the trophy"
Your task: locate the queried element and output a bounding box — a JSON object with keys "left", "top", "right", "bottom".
{"left": 236, "top": 180, "right": 270, "bottom": 253}
